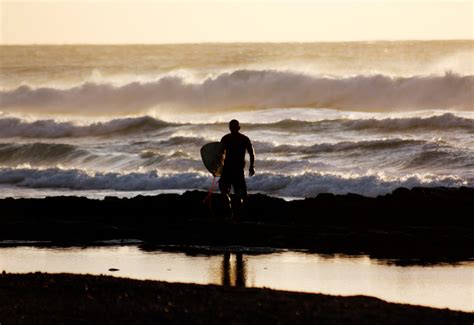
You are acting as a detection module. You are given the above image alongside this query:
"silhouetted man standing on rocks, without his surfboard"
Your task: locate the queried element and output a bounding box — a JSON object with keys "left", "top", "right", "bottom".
{"left": 219, "top": 120, "right": 255, "bottom": 221}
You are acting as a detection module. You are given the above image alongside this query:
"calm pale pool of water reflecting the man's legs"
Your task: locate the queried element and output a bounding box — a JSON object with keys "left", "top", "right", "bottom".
{"left": 0, "top": 245, "right": 474, "bottom": 312}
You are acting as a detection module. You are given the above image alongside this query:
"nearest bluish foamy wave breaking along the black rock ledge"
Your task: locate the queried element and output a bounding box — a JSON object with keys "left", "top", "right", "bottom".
{"left": 0, "top": 168, "right": 468, "bottom": 197}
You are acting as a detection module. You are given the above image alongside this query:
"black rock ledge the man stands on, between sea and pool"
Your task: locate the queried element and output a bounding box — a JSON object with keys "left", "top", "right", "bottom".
{"left": 0, "top": 187, "right": 474, "bottom": 262}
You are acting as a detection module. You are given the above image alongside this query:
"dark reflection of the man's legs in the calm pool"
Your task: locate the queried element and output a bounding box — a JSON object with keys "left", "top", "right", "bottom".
{"left": 221, "top": 252, "right": 247, "bottom": 287}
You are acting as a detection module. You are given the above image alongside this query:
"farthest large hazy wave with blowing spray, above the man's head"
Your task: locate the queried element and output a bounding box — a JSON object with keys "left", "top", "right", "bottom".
{"left": 0, "top": 70, "right": 474, "bottom": 115}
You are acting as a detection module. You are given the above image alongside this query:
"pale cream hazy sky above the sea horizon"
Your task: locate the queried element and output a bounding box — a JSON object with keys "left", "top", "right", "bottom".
{"left": 0, "top": 0, "right": 474, "bottom": 44}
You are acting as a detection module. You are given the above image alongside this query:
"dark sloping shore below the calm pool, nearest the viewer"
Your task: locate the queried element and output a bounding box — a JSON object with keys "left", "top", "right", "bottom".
{"left": 0, "top": 273, "right": 474, "bottom": 325}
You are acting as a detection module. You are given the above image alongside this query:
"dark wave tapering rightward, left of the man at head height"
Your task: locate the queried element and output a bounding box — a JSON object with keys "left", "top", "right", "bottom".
{"left": 0, "top": 116, "right": 174, "bottom": 138}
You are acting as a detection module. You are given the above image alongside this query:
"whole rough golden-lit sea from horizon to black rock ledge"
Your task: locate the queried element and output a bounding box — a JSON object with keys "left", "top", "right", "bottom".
{"left": 0, "top": 41, "right": 474, "bottom": 198}
